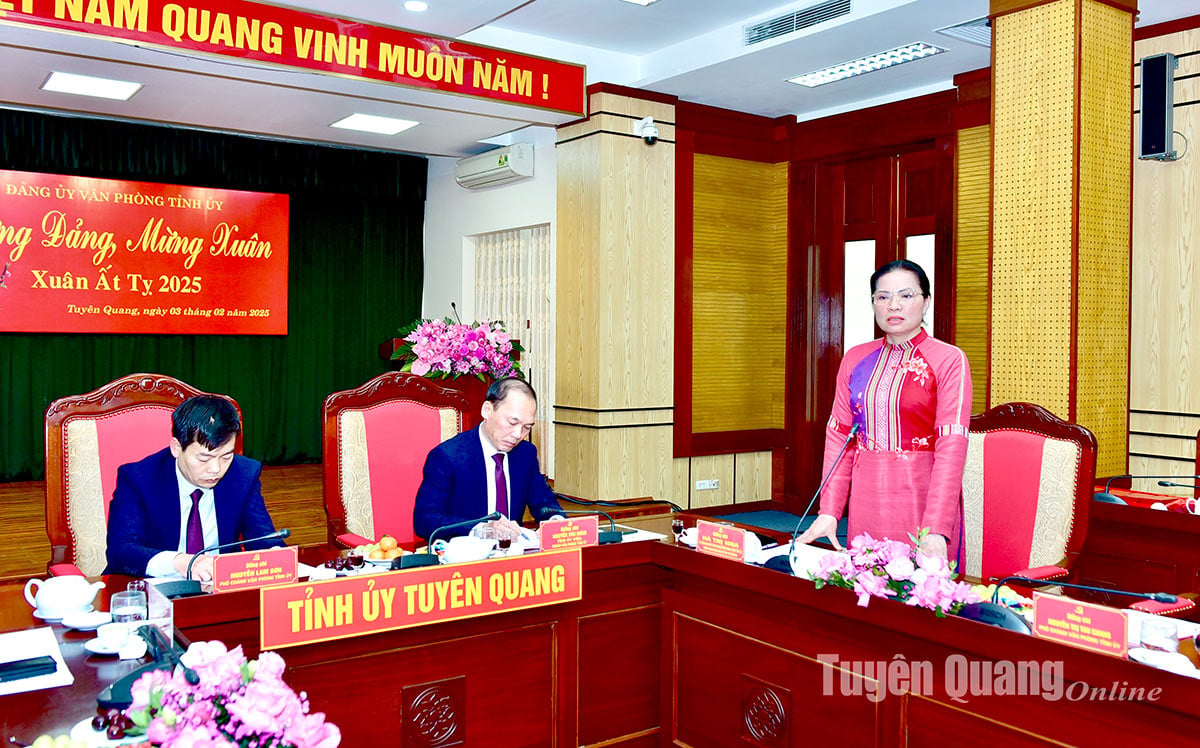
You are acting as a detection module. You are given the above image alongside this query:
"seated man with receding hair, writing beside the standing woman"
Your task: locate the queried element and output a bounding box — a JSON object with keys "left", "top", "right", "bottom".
{"left": 413, "top": 378, "right": 562, "bottom": 538}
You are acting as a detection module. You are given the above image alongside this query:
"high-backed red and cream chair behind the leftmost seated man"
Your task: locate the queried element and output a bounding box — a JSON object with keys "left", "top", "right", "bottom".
{"left": 46, "top": 373, "right": 241, "bottom": 576}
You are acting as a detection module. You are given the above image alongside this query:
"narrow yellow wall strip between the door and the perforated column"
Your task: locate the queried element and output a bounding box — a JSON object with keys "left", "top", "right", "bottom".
{"left": 954, "top": 125, "right": 991, "bottom": 413}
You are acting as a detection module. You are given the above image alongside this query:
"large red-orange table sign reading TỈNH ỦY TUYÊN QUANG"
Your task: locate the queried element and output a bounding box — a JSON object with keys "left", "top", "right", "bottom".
{"left": 258, "top": 549, "right": 583, "bottom": 650}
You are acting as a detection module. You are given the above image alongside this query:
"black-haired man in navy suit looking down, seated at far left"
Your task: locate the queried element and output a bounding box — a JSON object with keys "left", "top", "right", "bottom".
{"left": 104, "top": 395, "right": 283, "bottom": 581}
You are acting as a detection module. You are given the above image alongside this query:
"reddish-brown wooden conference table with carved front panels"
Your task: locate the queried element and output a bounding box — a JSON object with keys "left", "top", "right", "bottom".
{"left": 0, "top": 521, "right": 1200, "bottom": 748}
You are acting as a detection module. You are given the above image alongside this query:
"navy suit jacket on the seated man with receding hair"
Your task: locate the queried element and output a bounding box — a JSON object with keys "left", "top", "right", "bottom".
{"left": 413, "top": 426, "right": 562, "bottom": 538}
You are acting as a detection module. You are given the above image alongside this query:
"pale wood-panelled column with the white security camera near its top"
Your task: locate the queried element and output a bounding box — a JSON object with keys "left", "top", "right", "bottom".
{"left": 554, "top": 86, "right": 688, "bottom": 499}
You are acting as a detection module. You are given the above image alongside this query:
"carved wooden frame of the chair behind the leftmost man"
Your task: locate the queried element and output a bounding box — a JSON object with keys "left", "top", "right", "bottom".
{"left": 44, "top": 373, "right": 238, "bottom": 567}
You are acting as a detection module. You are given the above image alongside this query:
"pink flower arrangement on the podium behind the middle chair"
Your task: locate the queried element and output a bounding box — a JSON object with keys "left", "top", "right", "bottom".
{"left": 391, "top": 319, "right": 523, "bottom": 379}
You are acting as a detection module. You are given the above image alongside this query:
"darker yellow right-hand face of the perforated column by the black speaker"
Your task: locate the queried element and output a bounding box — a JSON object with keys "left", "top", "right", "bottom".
{"left": 1075, "top": 1, "right": 1133, "bottom": 475}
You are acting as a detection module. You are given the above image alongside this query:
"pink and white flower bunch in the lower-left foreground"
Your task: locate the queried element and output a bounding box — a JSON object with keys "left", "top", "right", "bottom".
{"left": 126, "top": 641, "right": 342, "bottom": 748}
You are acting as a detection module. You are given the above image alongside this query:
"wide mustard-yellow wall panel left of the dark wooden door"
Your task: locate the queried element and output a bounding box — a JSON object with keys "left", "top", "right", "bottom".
{"left": 691, "top": 154, "right": 787, "bottom": 432}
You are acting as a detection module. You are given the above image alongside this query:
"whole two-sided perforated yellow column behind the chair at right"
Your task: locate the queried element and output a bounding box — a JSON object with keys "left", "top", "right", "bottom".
{"left": 989, "top": 0, "right": 1136, "bottom": 474}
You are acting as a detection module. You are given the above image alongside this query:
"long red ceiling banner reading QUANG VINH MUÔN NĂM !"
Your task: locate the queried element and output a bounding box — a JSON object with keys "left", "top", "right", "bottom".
{"left": 0, "top": 0, "right": 586, "bottom": 115}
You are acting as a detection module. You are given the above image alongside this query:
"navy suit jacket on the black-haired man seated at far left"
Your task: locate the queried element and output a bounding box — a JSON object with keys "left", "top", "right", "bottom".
{"left": 104, "top": 449, "right": 283, "bottom": 576}
